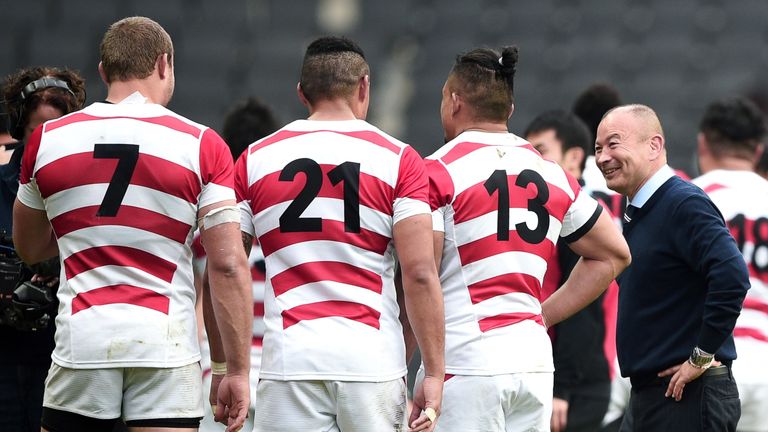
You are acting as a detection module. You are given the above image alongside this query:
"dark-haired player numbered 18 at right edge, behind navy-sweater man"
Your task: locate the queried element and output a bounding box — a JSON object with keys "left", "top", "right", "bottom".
{"left": 693, "top": 98, "right": 768, "bottom": 432}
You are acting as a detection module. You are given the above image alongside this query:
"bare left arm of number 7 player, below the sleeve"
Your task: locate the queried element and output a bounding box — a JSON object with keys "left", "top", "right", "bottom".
{"left": 13, "top": 199, "right": 59, "bottom": 264}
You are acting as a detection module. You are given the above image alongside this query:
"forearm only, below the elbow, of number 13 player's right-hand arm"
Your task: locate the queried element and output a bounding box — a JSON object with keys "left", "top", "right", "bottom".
{"left": 541, "top": 258, "right": 618, "bottom": 326}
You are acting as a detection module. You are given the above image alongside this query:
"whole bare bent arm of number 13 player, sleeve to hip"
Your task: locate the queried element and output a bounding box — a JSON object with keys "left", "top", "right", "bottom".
{"left": 541, "top": 212, "right": 631, "bottom": 326}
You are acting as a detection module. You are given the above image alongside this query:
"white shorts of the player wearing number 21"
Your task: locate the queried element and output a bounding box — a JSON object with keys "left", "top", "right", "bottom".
{"left": 253, "top": 378, "right": 408, "bottom": 432}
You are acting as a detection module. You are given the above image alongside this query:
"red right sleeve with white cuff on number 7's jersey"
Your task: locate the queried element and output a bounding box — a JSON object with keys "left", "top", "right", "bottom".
{"left": 198, "top": 129, "right": 235, "bottom": 208}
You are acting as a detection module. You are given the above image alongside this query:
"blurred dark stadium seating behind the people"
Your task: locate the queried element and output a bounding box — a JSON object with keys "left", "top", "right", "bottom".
{"left": 0, "top": 0, "right": 768, "bottom": 171}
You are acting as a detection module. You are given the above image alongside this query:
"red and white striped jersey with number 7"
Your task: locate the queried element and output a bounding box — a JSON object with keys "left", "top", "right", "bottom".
{"left": 18, "top": 93, "right": 235, "bottom": 369}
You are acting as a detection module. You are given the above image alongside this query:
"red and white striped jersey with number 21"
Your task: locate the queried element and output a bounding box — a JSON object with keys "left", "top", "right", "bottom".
{"left": 235, "top": 120, "right": 430, "bottom": 382}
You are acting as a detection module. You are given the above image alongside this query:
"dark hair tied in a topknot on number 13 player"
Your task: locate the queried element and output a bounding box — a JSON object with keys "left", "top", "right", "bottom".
{"left": 448, "top": 46, "right": 518, "bottom": 122}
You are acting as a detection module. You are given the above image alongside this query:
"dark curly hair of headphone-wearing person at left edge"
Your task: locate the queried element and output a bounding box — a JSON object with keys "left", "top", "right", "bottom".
{"left": 3, "top": 67, "right": 85, "bottom": 139}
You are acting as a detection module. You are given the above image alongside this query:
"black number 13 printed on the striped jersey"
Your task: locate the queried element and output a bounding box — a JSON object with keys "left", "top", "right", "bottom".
{"left": 484, "top": 169, "right": 549, "bottom": 244}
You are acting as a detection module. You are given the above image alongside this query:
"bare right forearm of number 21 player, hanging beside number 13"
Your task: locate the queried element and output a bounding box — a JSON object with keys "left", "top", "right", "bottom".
{"left": 403, "top": 277, "right": 445, "bottom": 378}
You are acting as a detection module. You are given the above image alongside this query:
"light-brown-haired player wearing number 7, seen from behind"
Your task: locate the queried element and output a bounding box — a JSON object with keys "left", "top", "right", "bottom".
{"left": 13, "top": 17, "right": 251, "bottom": 431}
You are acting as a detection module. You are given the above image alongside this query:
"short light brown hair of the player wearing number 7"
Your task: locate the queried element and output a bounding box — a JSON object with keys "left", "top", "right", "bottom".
{"left": 100, "top": 16, "right": 173, "bottom": 82}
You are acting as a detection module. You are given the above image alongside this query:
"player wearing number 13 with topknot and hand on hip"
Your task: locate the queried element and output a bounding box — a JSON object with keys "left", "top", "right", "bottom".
{"left": 427, "top": 47, "right": 629, "bottom": 431}
